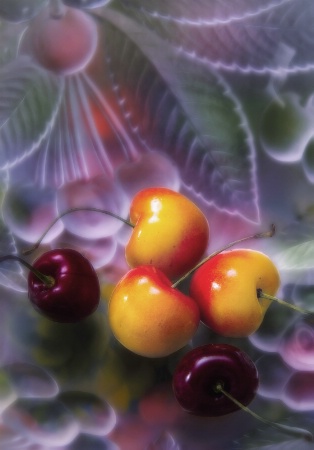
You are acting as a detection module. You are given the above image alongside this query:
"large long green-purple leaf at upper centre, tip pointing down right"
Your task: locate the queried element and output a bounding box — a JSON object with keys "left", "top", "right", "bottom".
{"left": 97, "top": 9, "right": 259, "bottom": 222}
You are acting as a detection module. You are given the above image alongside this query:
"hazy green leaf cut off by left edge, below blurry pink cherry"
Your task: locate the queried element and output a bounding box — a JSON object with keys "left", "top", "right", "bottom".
{"left": 0, "top": 57, "right": 63, "bottom": 170}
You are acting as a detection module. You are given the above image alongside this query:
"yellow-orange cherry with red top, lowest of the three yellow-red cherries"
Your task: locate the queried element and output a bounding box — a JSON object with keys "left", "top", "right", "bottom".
{"left": 108, "top": 265, "right": 199, "bottom": 358}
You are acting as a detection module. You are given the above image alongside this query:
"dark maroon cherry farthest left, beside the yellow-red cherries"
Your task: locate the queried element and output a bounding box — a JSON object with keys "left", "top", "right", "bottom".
{"left": 28, "top": 248, "right": 100, "bottom": 323}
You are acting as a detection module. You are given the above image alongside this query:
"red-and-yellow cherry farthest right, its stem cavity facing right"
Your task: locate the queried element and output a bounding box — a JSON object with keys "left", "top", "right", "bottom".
{"left": 189, "top": 249, "right": 280, "bottom": 337}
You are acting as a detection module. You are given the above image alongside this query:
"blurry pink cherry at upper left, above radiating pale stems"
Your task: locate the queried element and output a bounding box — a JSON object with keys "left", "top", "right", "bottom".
{"left": 21, "top": 7, "right": 97, "bottom": 74}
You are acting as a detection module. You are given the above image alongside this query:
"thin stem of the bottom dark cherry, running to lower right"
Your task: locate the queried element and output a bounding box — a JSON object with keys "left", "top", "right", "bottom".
{"left": 215, "top": 383, "right": 314, "bottom": 442}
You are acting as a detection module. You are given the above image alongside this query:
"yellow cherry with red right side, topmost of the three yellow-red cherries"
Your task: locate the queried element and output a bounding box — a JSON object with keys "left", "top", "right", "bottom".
{"left": 125, "top": 187, "right": 209, "bottom": 279}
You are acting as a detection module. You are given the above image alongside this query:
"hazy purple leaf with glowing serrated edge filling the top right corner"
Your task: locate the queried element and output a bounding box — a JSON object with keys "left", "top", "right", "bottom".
{"left": 116, "top": 0, "right": 314, "bottom": 74}
